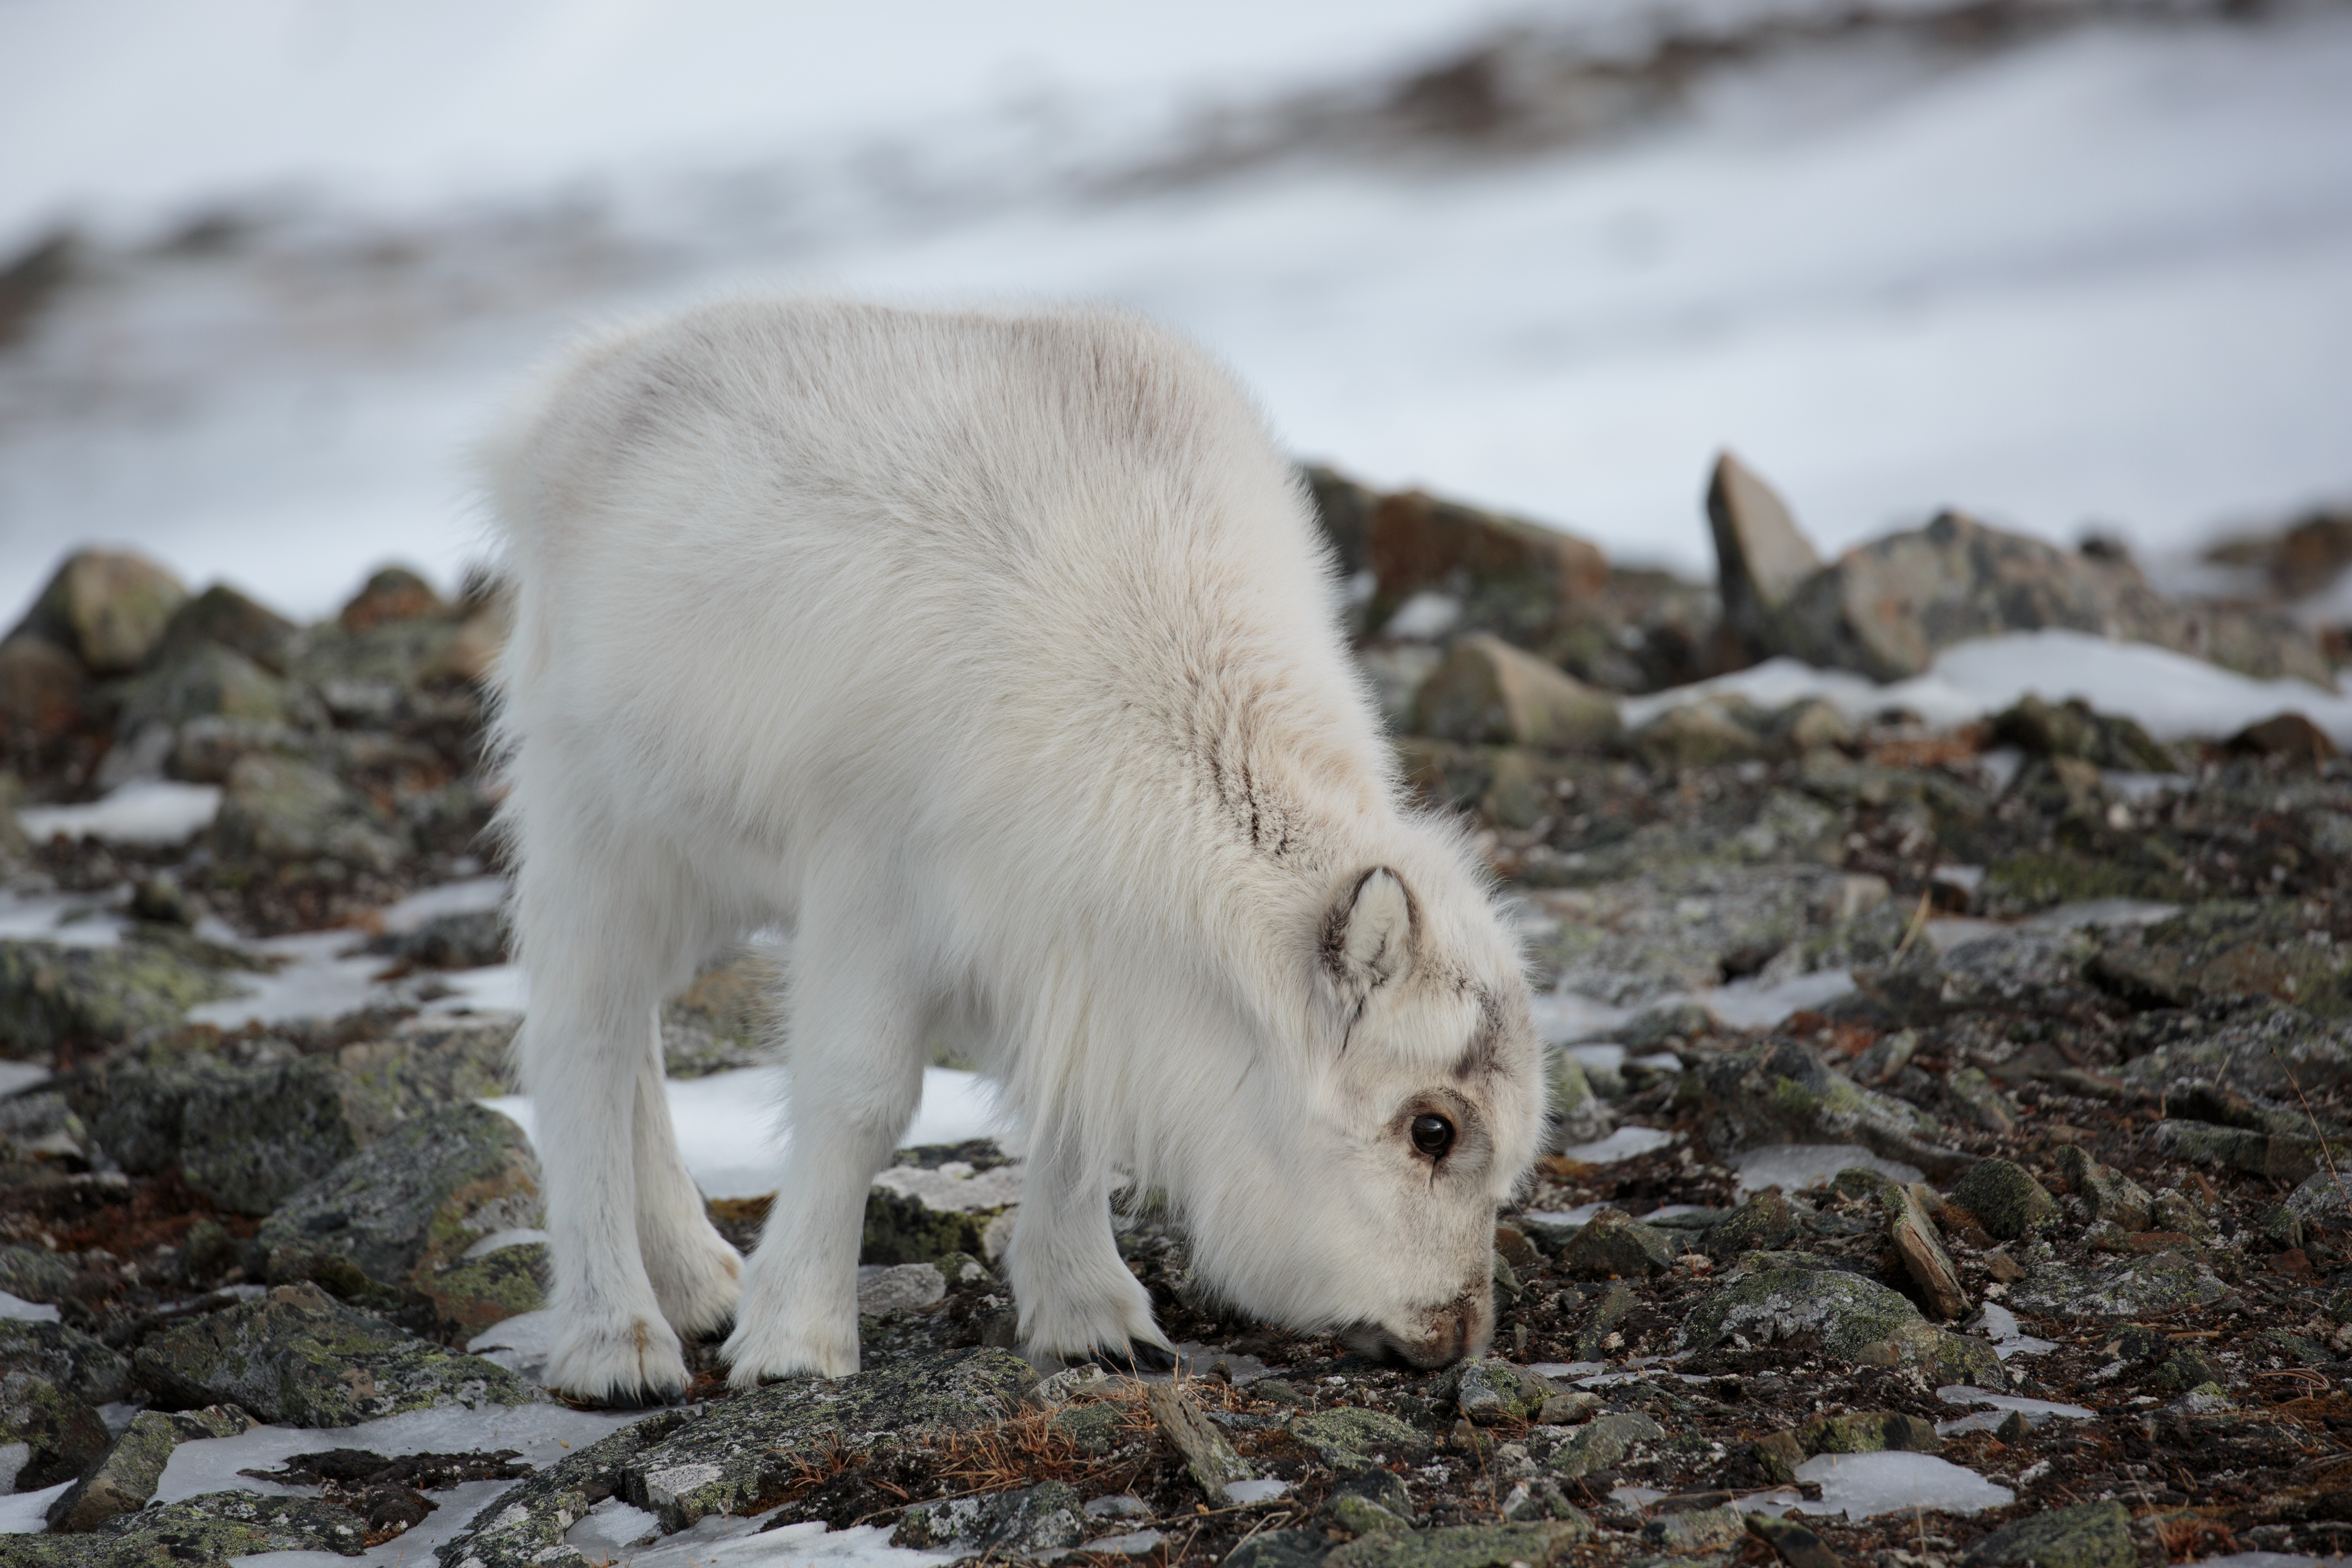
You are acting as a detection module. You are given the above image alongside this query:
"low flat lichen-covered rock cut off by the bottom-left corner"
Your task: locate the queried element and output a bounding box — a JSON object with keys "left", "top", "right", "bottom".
{"left": 0, "top": 1493, "right": 367, "bottom": 1568}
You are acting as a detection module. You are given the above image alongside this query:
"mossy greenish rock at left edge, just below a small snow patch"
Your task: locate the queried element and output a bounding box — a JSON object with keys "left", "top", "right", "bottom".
{"left": 0, "top": 926, "right": 244, "bottom": 1060}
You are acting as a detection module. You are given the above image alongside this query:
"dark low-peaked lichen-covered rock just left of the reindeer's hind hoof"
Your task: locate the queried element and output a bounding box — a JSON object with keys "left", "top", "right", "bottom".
{"left": 132, "top": 1281, "right": 532, "bottom": 1427}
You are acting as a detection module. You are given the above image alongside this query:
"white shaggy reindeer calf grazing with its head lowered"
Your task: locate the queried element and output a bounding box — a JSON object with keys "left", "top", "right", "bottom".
{"left": 492, "top": 301, "right": 1543, "bottom": 1399}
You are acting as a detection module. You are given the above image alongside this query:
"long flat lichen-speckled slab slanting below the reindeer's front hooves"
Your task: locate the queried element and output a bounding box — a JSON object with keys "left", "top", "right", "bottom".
{"left": 440, "top": 1350, "right": 1037, "bottom": 1568}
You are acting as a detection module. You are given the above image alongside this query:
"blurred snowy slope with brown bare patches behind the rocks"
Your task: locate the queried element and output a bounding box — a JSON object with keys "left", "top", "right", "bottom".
{"left": 0, "top": 0, "right": 2352, "bottom": 616}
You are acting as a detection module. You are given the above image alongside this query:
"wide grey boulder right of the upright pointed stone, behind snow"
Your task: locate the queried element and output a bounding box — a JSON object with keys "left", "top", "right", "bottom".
{"left": 1769, "top": 512, "right": 2333, "bottom": 689}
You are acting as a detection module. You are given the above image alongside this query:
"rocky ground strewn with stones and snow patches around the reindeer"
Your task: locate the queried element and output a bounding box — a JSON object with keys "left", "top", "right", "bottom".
{"left": 0, "top": 466, "right": 2352, "bottom": 1568}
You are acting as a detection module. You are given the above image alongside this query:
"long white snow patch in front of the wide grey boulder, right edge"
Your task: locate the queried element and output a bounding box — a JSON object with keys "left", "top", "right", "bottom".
{"left": 1623, "top": 630, "right": 2352, "bottom": 747}
